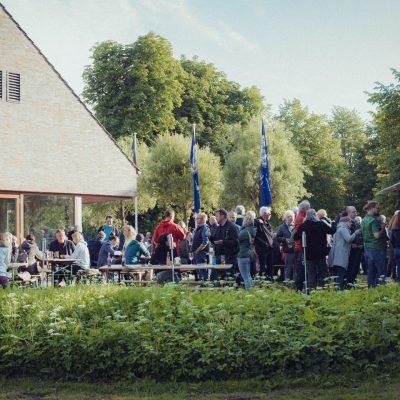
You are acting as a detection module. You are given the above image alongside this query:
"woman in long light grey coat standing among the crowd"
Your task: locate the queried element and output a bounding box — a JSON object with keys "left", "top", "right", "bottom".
{"left": 331, "top": 217, "right": 360, "bottom": 290}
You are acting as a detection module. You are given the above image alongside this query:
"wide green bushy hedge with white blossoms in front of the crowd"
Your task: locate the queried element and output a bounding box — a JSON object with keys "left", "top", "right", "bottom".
{"left": 0, "top": 285, "right": 400, "bottom": 381}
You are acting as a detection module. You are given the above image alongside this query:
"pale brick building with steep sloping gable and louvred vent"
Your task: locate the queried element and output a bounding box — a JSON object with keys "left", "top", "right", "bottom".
{"left": 0, "top": 3, "right": 138, "bottom": 244}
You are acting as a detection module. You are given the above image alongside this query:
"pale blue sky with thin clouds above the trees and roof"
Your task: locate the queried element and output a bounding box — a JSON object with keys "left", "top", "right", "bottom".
{"left": 0, "top": 0, "right": 400, "bottom": 120}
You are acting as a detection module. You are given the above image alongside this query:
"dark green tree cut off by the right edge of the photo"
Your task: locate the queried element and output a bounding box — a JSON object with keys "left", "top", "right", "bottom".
{"left": 368, "top": 69, "right": 400, "bottom": 215}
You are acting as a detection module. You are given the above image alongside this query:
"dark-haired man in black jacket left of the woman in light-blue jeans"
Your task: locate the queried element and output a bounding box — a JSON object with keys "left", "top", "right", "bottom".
{"left": 208, "top": 208, "right": 239, "bottom": 280}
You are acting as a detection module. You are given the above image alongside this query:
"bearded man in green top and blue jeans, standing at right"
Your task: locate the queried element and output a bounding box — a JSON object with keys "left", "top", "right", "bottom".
{"left": 361, "top": 201, "right": 387, "bottom": 288}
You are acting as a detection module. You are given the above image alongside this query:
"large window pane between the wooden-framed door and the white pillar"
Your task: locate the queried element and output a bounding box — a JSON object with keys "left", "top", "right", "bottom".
{"left": 24, "top": 195, "right": 74, "bottom": 243}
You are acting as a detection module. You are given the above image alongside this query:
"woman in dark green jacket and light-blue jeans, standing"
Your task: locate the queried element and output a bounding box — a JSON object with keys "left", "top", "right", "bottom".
{"left": 237, "top": 215, "right": 256, "bottom": 290}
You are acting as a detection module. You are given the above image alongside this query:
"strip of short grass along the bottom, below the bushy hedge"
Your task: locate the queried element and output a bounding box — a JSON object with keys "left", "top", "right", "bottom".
{"left": 0, "top": 375, "right": 400, "bottom": 400}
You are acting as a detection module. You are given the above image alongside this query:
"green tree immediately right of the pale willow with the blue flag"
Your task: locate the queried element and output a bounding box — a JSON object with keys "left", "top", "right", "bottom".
{"left": 278, "top": 99, "right": 345, "bottom": 213}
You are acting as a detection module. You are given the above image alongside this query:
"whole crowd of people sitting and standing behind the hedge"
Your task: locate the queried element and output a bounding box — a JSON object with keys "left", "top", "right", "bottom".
{"left": 0, "top": 200, "right": 400, "bottom": 291}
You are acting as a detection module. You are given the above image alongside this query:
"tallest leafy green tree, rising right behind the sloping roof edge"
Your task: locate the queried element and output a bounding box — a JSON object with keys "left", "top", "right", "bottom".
{"left": 83, "top": 32, "right": 183, "bottom": 144}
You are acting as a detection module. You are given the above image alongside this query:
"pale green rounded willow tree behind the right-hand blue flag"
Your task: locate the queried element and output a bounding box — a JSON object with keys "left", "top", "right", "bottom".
{"left": 221, "top": 119, "right": 306, "bottom": 217}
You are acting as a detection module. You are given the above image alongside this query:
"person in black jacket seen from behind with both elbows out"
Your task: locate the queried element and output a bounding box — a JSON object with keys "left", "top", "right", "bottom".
{"left": 294, "top": 208, "right": 336, "bottom": 290}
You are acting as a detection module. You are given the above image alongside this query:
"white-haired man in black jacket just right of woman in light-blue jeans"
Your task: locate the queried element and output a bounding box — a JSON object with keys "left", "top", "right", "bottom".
{"left": 254, "top": 207, "right": 274, "bottom": 281}
